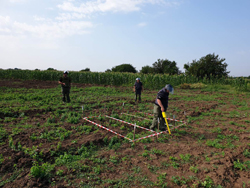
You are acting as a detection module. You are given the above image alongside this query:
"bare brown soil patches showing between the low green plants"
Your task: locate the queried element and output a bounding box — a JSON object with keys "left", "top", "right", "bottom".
{"left": 0, "top": 80, "right": 250, "bottom": 188}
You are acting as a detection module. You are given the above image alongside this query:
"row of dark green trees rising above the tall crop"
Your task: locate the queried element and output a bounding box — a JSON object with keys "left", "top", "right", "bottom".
{"left": 105, "top": 53, "right": 229, "bottom": 79}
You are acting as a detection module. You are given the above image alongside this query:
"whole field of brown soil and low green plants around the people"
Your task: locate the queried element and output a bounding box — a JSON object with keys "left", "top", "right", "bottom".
{"left": 0, "top": 79, "right": 250, "bottom": 188}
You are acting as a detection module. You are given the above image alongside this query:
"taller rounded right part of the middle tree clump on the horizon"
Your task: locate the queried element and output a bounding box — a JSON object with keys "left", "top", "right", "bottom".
{"left": 153, "top": 59, "right": 181, "bottom": 75}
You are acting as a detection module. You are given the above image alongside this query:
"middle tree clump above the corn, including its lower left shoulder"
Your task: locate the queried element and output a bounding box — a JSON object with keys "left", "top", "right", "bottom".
{"left": 140, "top": 59, "right": 181, "bottom": 75}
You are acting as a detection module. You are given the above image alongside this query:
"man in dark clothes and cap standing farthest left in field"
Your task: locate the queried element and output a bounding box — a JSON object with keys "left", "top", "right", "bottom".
{"left": 58, "top": 71, "right": 71, "bottom": 102}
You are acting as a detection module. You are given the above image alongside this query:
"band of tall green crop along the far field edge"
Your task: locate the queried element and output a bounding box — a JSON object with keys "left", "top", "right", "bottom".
{"left": 0, "top": 69, "right": 250, "bottom": 91}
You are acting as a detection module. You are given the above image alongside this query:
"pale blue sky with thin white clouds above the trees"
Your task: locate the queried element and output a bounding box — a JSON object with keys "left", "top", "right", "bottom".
{"left": 0, "top": 0, "right": 250, "bottom": 76}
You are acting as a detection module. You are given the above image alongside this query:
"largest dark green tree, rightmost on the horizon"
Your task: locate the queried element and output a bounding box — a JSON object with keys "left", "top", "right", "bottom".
{"left": 184, "top": 53, "right": 229, "bottom": 78}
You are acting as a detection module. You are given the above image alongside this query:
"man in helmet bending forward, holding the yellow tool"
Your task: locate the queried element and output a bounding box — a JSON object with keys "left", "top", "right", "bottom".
{"left": 150, "top": 84, "right": 174, "bottom": 131}
